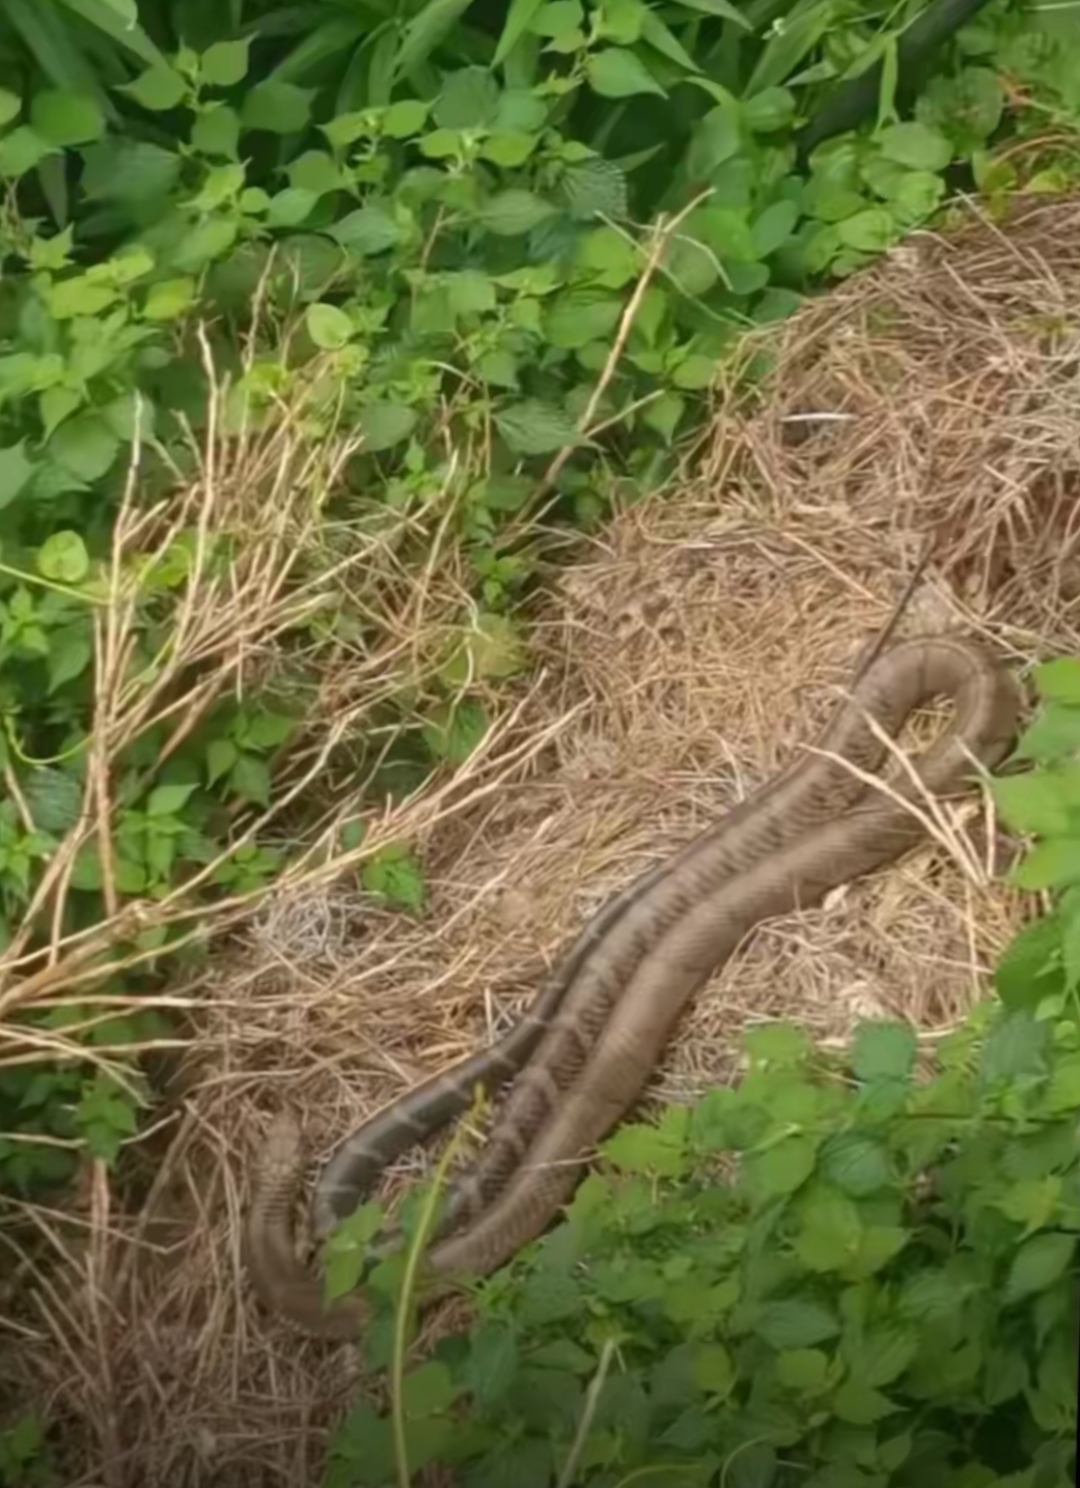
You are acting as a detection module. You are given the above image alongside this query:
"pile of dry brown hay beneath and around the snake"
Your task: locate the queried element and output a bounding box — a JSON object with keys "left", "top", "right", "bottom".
{"left": 10, "top": 191, "right": 1080, "bottom": 1488}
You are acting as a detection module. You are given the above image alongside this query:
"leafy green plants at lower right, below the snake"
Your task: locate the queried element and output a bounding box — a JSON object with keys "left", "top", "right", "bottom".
{"left": 324, "top": 661, "right": 1080, "bottom": 1488}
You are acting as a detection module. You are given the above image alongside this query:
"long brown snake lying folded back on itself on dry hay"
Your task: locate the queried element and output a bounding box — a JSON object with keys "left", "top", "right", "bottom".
{"left": 247, "top": 637, "right": 1020, "bottom": 1338}
